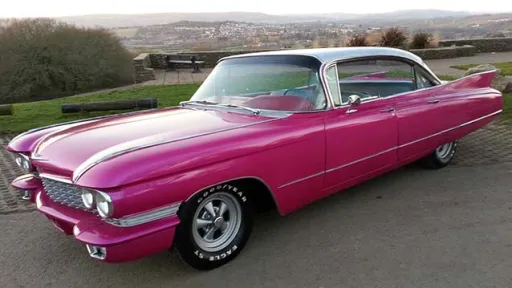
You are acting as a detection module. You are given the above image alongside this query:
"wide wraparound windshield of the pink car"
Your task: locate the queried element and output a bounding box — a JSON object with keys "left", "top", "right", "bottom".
{"left": 190, "top": 55, "right": 326, "bottom": 112}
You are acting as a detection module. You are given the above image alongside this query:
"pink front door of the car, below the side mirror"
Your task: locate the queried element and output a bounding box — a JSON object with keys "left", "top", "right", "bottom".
{"left": 325, "top": 63, "right": 398, "bottom": 192}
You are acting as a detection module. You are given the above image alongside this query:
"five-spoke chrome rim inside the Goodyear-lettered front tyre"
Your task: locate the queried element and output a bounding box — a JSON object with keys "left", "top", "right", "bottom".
{"left": 192, "top": 192, "right": 242, "bottom": 252}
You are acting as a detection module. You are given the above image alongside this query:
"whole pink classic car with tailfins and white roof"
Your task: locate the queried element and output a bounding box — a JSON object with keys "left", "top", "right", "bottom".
{"left": 8, "top": 47, "right": 503, "bottom": 270}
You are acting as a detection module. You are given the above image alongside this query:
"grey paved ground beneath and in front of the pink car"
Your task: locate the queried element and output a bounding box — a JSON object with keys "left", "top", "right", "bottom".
{"left": 0, "top": 118, "right": 512, "bottom": 288}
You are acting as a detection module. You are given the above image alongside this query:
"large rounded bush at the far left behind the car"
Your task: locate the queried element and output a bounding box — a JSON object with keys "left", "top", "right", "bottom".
{"left": 0, "top": 18, "right": 133, "bottom": 103}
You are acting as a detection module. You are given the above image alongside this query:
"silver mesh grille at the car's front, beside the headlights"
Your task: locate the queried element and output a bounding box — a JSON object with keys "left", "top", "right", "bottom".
{"left": 41, "top": 178, "right": 92, "bottom": 212}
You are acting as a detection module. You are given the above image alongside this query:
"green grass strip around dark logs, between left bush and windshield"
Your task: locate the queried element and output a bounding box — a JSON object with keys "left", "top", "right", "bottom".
{"left": 0, "top": 84, "right": 199, "bottom": 133}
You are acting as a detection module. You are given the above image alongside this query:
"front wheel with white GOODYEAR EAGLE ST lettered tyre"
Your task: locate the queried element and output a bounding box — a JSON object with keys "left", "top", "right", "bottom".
{"left": 175, "top": 184, "right": 253, "bottom": 270}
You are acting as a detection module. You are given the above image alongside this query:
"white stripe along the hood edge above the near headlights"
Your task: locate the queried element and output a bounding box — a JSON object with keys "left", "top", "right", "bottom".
{"left": 73, "top": 115, "right": 290, "bottom": 183}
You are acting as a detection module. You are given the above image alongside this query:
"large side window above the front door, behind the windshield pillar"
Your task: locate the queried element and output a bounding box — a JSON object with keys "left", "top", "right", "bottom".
{"left": 338, "top": 59, "right": 414, "bottom": 103}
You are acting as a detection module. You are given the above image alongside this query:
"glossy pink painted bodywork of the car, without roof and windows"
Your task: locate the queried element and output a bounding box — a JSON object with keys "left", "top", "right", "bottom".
{"left": 8, "top": 47, "right": 503, "bottom": 262}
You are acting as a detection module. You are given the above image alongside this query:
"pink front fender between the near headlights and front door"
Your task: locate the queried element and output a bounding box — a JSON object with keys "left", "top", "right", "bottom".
{"left": 76, "top": 115, "right": 325, "bottom": 215}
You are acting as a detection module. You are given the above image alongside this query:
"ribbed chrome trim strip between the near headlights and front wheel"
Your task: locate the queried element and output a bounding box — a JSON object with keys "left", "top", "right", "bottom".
{"left": 104, "top": 202, "right": 182, "bottom": 227}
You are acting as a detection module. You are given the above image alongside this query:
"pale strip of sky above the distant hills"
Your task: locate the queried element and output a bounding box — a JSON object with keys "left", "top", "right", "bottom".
{"left": 0, "top": 0, "right": 512, "bottom": 18}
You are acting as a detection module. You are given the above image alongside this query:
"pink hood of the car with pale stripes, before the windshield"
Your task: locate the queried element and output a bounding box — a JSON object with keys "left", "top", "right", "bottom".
{"left": 32, "top": 108, "right": 269, "bottom": 174}
